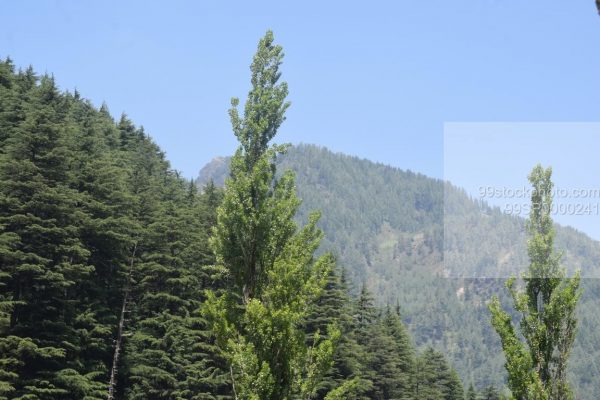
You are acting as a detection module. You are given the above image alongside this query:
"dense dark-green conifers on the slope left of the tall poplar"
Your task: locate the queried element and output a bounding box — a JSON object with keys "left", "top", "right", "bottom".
{"left": 0, "top": 60, "right": 229, "bottom": 400}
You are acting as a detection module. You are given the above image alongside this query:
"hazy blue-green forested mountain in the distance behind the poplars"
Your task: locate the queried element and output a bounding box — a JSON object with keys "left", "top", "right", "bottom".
{"left": 197, "top": 145, "right": 600, "bottom": 398}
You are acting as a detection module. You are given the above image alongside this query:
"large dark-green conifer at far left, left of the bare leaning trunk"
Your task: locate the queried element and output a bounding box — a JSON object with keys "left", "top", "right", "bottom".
{"left": 0, "top": 70, "right": 109, "bottom": 399}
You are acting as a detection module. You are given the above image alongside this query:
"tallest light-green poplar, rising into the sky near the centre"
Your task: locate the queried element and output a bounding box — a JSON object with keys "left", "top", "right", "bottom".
{"left": 205, "top": 32, "right": 339, "bottom": 400}
